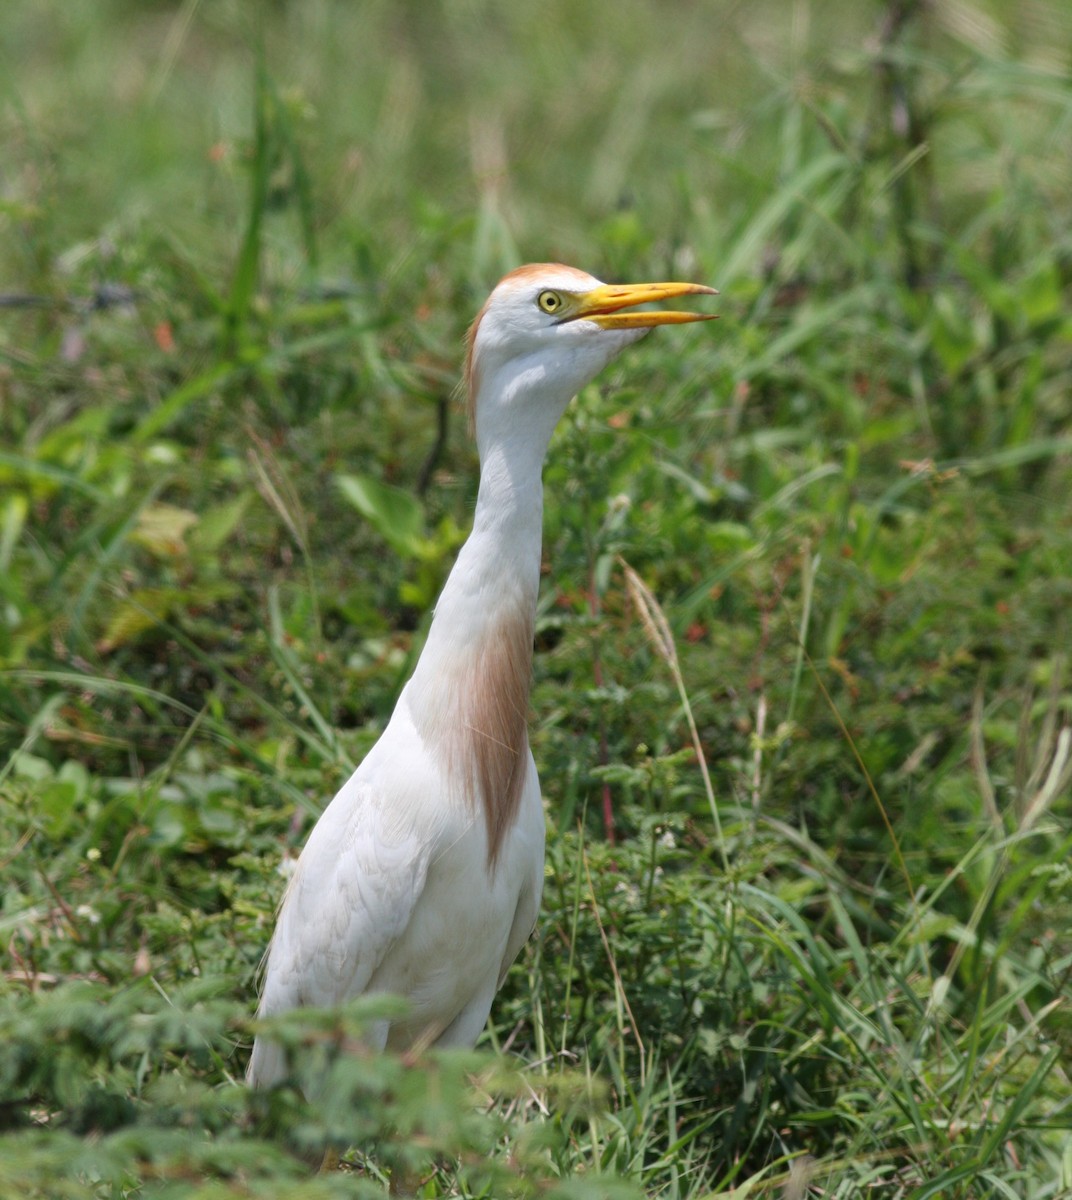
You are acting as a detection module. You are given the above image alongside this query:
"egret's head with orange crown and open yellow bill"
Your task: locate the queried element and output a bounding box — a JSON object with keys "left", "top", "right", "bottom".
{"left": 465, "top": 263, "right": 717, "bottom": 454}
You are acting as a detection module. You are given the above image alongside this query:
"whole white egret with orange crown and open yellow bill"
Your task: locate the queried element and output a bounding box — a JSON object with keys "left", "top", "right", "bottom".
{"left": 247, "top": 263, "right": 715, "bottom": 1087}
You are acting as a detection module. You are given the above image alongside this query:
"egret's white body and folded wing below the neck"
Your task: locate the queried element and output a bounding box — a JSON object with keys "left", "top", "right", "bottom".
{"left": 247, "top": 715, "right": 544, "bottom": 1087}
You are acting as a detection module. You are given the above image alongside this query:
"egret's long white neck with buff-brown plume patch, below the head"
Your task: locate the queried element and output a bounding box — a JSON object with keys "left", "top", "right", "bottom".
{"left": 407, "top": 420, "right": 546, "bottom": 865}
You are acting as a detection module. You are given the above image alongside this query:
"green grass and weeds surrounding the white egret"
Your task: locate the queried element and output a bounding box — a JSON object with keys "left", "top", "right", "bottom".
{"left": 0, "top": 0, "right": 1072, "bottom": 1200}
